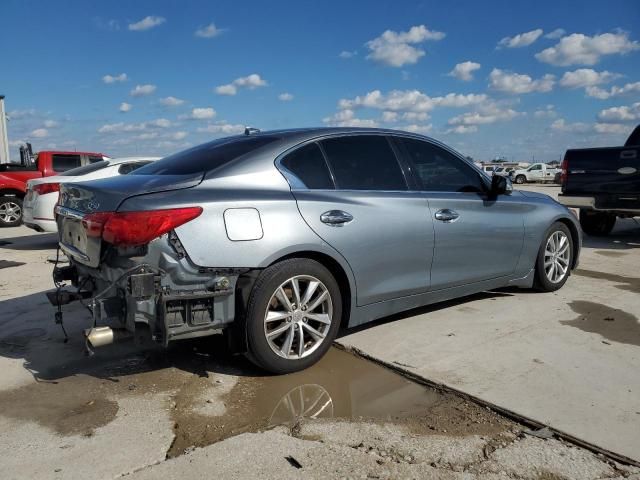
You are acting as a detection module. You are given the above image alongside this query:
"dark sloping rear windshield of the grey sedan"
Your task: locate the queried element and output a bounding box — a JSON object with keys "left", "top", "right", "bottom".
{"left": 130, "top": 136, "right": 279, "bottom": 175}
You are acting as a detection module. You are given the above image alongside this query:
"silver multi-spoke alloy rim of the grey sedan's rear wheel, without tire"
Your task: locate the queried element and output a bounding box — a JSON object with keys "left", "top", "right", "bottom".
{"left": 264, "top": 275, "right": 333, "bottom": 360}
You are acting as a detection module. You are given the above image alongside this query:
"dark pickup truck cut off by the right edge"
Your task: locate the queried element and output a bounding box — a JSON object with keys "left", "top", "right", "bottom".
{"left": 558, "top": 125, "right": 640, "bottom": 236}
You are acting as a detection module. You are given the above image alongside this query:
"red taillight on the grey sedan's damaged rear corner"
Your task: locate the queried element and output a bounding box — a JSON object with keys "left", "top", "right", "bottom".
{"left": 82, "top": 207, "right": 202, "bottom": 247}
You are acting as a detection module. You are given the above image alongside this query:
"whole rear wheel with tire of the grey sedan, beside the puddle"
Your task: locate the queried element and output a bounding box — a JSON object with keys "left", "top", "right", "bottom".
{"left": 246, "top": 258, "right": 342, "bottom": 374}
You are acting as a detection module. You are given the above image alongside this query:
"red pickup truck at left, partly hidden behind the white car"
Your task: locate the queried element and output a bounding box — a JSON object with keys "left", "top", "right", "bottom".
{"left": 0, "top": 151, "right": 105, "bottom": 228}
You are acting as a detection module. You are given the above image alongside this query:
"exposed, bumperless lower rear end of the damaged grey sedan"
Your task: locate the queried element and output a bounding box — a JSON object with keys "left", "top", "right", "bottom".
{"left": 48, "top": 235, "right": 246, "bottom": 346}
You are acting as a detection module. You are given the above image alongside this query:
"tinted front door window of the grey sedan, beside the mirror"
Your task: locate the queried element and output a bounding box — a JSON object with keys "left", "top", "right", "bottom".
{"left": 398, "top": 138, "right": 485, "bottom": 193}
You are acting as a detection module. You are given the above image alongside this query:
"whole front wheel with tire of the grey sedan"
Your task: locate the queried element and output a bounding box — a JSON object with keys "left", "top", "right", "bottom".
{"left": 535, "top": 222, "right": 574, "bottom": 292}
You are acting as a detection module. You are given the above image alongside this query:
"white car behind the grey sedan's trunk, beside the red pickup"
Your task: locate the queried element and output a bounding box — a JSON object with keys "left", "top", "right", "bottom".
{"left": 22, "top": 157, "right": 159, "bottom": 232}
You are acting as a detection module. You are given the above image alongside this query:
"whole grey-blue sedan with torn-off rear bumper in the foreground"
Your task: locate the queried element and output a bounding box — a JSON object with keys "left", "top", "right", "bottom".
{"left": 50, "top": 128, "right": 581, "bottom": 373}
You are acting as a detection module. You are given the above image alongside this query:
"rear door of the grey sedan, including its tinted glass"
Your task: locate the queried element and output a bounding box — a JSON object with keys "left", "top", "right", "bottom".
{"left": 280, "top": 134, "right": 433, "bottom": 305}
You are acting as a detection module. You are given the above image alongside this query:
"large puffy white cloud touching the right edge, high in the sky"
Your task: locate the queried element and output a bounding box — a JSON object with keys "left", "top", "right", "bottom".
{"left": 535, "top": 31, "right": 640, "bottom": 67}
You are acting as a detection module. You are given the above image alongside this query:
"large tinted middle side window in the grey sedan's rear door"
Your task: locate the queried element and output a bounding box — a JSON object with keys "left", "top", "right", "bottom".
{"left": 322, "top": 135, "right": 407, "bottom": 190}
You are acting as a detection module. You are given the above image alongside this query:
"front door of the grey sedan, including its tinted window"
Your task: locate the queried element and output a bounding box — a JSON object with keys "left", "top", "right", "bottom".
{"left": 397, "top": 137, "right": 526, "bottom": 290}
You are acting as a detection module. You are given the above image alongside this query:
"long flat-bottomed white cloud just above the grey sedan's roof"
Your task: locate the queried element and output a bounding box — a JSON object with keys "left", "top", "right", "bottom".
{"left": 338, "top": 90, "right": 488, "bottom": 112}
